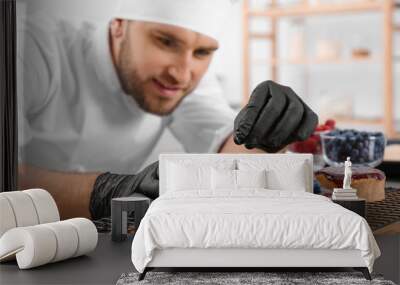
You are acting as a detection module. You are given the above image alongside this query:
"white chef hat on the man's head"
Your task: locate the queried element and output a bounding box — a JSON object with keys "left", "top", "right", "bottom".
{"left": 114, "top": 0, "right": 234, "bottom": 40}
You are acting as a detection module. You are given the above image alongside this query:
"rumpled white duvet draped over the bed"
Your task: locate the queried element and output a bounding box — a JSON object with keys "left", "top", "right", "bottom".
{"left": 132, "top": 189, "right": 380, "bottom": 272}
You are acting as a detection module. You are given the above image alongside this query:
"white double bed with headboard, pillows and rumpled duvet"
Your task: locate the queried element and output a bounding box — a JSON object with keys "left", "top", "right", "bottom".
{"left": 132, "top": 154, "right": 380, "bottom": 279}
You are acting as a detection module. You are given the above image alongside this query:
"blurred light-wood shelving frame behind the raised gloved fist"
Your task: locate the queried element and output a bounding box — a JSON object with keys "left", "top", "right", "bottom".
{"left": 242, "top": 0, "right": 400, "bottom": 138}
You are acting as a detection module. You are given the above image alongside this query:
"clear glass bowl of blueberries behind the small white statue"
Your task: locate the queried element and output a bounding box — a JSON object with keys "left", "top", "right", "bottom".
{"left": 321, "top": 129, "right": 386, "bottom": 167}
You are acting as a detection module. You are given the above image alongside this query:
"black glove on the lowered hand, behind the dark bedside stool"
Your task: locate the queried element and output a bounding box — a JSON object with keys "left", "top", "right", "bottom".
{"left": 89, "top": 161, "right": 159, "bottom": 219}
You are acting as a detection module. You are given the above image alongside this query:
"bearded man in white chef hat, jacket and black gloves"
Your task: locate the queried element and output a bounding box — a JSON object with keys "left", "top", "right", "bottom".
{"left": 18, "top": 0, "right": 318, "bottom": 218}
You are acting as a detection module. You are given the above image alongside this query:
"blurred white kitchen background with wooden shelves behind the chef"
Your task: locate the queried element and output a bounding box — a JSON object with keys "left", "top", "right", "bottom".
{"left": 17, "top": 0, "right": 400, "bottom": 164}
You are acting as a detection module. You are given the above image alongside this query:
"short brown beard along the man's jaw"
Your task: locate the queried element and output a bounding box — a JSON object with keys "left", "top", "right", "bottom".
{"left": 116, "top": 40, "right": 193, "bottom": 116}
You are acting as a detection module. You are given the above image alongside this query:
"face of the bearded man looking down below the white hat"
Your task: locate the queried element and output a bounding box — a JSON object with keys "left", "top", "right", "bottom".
{"left": 111, "top": 20, "right": 218, "bottom": 115}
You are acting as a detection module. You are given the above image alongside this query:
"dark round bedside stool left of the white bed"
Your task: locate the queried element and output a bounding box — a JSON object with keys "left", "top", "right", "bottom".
{"left": 111, "top": 193, "right": 151, "bottom": 241}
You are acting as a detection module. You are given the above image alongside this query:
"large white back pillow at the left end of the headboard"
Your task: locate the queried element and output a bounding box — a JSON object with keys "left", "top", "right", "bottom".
{"left": 167, "top": 163, "right": 211, "bottom": 191}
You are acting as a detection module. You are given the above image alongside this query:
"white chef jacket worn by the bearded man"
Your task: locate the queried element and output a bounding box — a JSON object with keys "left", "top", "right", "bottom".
{"left": 18, "top": 18, "right": 235, "bottom": 173}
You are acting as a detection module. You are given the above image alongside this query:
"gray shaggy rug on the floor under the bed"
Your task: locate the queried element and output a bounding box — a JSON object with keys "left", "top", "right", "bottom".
{"left": 117, "top": 272, "right": 395, "bottom": 285}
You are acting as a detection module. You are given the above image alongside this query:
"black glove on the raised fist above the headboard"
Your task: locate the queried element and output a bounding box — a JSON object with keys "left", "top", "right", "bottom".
{"left": 234, "top": 80, "right": 318, "bottom": 152}
